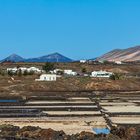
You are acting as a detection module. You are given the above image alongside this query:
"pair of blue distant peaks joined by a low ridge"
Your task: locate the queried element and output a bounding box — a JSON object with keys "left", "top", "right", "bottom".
{"left": 1, "top": 53, "right": 73, "bottom": 62}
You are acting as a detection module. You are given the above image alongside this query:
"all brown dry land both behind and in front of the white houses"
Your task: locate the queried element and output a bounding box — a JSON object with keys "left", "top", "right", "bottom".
{"left": 0, "top": 63, "right": 140, "bottom": 95}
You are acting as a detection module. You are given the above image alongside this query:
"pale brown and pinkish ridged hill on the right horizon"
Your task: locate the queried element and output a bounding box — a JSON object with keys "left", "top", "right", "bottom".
{"left": 97, "top": 46, "right": 140, "bottom": 61}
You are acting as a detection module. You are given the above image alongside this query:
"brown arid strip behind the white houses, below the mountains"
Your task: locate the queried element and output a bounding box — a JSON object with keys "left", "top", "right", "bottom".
{"left": 0, "top": 62, "right": 140, "bottom": 73}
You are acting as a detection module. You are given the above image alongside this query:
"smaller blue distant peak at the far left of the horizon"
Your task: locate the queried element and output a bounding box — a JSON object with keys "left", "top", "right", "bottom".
{"left": 1, "top": 54, "right": 25, "bottom": 62}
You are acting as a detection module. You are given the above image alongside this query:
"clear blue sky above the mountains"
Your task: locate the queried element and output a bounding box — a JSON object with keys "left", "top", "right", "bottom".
{"left": 0, "top": 0, "right": 140, "bottom": 59}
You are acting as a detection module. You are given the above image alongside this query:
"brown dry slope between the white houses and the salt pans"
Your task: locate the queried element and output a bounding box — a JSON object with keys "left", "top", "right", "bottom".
{"left": 0, "top": 75, "right": 140, "bottom": 96}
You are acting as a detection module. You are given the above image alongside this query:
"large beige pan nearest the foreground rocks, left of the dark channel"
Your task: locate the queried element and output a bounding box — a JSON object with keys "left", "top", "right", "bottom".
{"left": 0, "top": 117, "right": 106, "bottom": 134}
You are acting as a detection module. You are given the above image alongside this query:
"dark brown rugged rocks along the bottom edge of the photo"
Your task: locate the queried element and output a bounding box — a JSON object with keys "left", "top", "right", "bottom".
{"left": 0, "top": 125, "right": 140, "bottom": 140}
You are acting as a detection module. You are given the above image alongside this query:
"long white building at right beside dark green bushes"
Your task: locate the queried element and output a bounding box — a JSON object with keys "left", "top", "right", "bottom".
{"left": 91, "top": 71, "right": 113, "bottom": 78}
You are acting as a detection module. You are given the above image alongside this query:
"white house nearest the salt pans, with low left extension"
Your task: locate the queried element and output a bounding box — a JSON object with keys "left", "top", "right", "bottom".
{"left": 35, "top": 74, "right": 57, "bottom": 81}
